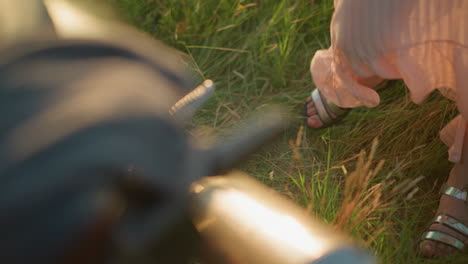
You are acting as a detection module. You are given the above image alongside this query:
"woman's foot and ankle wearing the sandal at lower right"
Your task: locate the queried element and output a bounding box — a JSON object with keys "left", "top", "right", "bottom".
{"left": 419, "top": 157, "right": 468, "bottom": 258}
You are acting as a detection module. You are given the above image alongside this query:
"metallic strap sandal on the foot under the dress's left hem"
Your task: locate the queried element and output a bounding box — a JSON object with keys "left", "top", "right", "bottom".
{"left": 304, "top": 89, "right": 350, "bottom": 127}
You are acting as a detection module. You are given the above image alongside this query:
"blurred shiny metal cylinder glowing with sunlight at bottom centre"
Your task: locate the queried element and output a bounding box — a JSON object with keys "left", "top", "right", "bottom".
{"left": 188, "top": 172, "right": 372, "bottom": 264}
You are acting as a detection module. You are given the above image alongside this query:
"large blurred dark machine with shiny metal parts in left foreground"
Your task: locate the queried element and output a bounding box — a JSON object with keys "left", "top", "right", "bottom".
{"left": 0, "top": 0, "right": 372, "bottom": 264}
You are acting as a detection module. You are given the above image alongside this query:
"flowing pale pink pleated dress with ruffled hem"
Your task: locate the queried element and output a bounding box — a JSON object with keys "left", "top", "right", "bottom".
{"left": 310, "top": 0, "right": 468, "bottom": 162}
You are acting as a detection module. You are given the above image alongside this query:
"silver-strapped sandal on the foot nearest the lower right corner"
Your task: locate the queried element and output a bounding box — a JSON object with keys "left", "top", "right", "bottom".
{"left": 421, "top": 184, "right": 468, "bottom": 251}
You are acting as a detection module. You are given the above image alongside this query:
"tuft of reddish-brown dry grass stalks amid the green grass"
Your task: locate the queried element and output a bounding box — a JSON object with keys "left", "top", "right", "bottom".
{"left": 335, "top": 140, "right": 423, "bottom": 244}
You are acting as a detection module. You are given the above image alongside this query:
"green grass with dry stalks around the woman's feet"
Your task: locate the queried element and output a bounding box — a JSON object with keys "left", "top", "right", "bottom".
{"left": 111, "top": 0, "right": 468, "bottom": 264}
